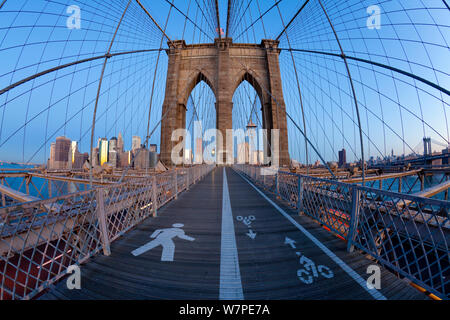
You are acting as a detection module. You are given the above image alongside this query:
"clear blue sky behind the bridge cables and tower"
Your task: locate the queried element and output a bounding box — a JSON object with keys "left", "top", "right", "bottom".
{"left": 0, "top": 0, "right": 450, "bottom": 162}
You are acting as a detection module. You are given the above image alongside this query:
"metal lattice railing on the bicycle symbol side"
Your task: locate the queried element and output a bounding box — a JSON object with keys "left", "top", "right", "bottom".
{"left": 234, "top": 165, "right": 450, "bottom": 299}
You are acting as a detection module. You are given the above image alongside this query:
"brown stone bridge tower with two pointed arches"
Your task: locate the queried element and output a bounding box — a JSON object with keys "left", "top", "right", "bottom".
{"left": 161, "top": 38, "right": 290, "bottom": 166}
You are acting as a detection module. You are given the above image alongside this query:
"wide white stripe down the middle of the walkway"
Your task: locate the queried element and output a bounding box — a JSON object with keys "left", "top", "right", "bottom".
{"left": 219, "top": 168, "right": 244, "bottom": 300}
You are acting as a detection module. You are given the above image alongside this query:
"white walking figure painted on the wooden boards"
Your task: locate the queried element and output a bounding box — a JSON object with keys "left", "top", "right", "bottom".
{"left": 131, "top": 223, "right": 195, "bottom": 261}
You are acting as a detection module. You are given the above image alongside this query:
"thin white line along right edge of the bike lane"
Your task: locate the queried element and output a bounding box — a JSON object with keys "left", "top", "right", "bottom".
{"left": 235, "top": 171, "right": 387, "bottom": 300}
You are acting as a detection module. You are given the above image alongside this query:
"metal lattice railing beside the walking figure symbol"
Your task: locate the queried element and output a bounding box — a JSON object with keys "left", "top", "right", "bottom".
{"left": 0, "top": 165, "right": 214, "bottom": 300}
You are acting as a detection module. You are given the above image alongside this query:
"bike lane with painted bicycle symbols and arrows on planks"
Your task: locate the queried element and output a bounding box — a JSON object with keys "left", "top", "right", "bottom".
{"left": 226, "top": 169, "right": 384, "bottom": 300}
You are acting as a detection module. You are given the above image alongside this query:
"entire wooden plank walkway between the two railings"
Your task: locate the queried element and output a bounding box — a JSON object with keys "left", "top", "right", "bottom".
{"left": 40, "top": 167, "right": 426, "bottom": 300}
